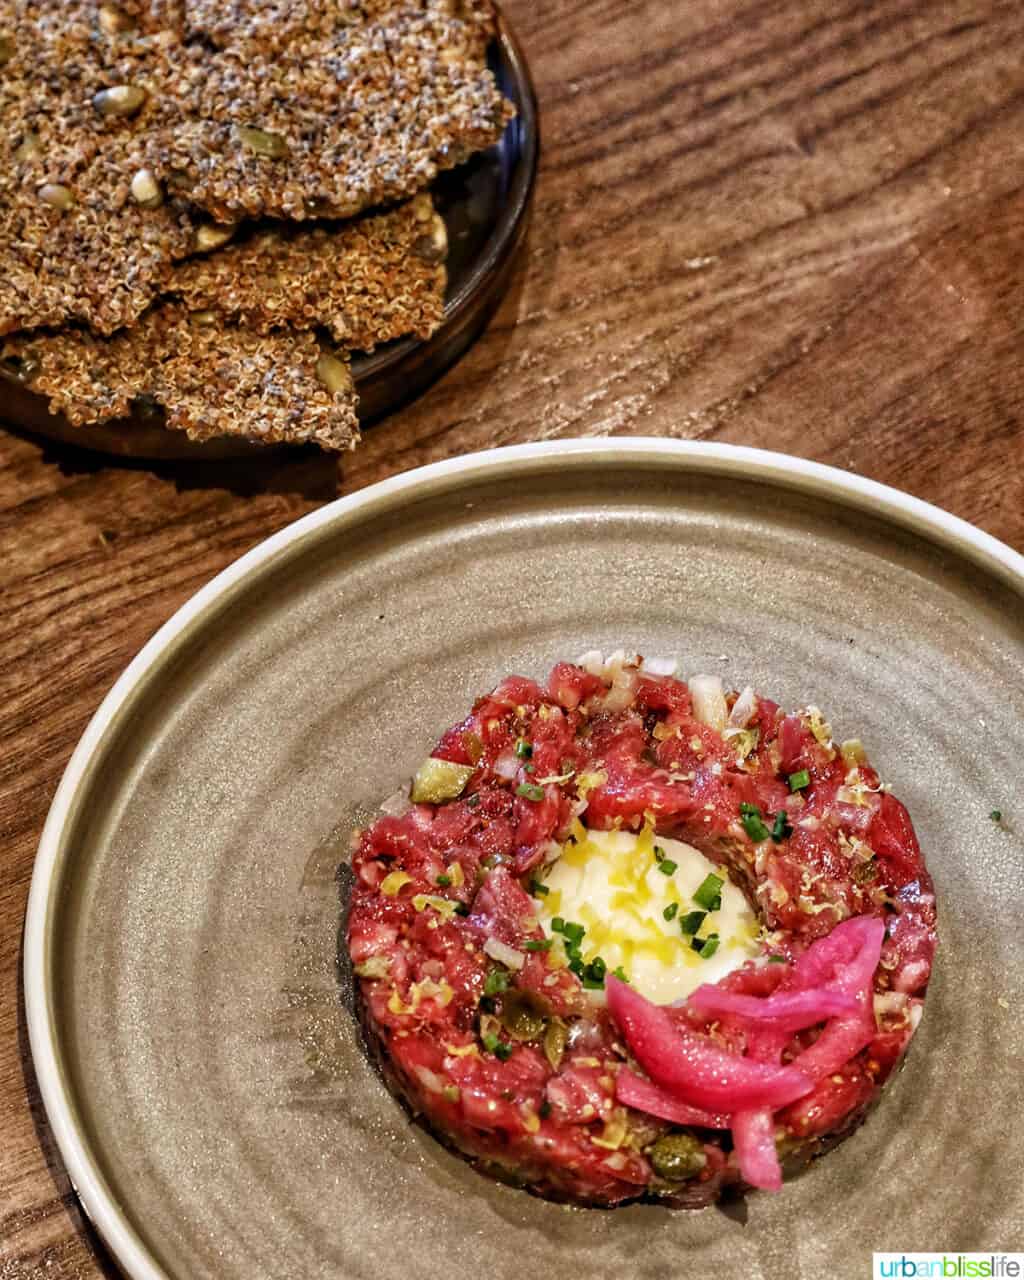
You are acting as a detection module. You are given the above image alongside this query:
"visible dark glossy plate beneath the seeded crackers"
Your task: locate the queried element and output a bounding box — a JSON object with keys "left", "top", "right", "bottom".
{"left": 0, "top": 14, "right": 540, "bottom": 460}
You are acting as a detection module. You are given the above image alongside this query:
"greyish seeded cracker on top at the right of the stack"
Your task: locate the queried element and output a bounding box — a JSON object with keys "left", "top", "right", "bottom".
{"left": 145, "top": 4, "right": 513, "bottom": 221}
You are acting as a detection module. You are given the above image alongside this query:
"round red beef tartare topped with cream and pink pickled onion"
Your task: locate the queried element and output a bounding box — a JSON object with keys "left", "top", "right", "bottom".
{"left": 348, "top": 654, "right": 936, "bottom": 1207}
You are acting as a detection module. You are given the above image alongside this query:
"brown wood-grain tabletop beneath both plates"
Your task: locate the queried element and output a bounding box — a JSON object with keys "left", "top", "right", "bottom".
{"left": 0, "top": 0, "right": 1024, "bottom": 1280}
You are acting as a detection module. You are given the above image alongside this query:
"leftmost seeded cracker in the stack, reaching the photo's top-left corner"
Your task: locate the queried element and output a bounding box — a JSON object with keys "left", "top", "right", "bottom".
{"left": 0, "top": 0, "right": 195, "bottom": 334}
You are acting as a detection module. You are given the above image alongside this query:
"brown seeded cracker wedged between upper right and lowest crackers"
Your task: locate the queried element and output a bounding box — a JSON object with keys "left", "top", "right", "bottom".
{"left": 169, "top": 192, "right": 447, "bottom": 351}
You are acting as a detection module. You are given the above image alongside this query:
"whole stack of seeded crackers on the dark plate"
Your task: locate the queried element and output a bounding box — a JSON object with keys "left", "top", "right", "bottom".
{"left": 0, "top": 0, "right": 513, "bottom": 449}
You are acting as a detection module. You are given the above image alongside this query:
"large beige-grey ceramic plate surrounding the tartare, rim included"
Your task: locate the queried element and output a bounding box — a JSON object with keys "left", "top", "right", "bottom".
{"left": 26, "top": 439, "right": 1024, "bottom": 1280}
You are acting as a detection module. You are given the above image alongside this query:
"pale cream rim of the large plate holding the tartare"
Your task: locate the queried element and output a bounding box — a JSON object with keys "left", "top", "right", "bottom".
{"left": 22, "top": 436, "right": 1024, "bottom": 1280}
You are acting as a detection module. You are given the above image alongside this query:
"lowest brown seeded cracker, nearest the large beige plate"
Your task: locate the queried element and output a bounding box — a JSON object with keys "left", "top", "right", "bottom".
{"left": 5, "top": 303, "right": 358, "bottom": 449}
